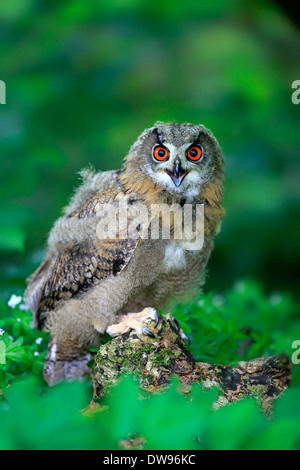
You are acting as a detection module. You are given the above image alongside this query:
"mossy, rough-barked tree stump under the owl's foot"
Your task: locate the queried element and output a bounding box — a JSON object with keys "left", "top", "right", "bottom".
{"left": 91, "top": 314, "right": 291, "bottom": 412}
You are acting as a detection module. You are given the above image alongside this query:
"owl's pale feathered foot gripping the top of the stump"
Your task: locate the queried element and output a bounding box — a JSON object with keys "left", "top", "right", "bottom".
{"left": 106, "top": 307, "right": 158, "bottom": 337}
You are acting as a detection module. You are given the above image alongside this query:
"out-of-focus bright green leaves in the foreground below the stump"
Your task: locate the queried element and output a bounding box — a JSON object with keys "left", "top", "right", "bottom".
{"left": 0, "top": 377, "right": 300, "bottom": 450}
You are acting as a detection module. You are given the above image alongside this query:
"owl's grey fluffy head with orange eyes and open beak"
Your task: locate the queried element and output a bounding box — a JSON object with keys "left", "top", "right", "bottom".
{"left": 126, "top": 122, "right": 223, "bottom": 197}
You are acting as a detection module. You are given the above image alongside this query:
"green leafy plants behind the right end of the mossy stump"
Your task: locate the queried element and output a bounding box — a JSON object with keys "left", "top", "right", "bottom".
{"left": 173, "top": 281, "right": 300, "bottom": 374}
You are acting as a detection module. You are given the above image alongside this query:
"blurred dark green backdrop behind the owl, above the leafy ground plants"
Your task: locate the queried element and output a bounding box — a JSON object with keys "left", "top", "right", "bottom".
{"left": 0, "top": 0, "right": 300, "bottom": 298}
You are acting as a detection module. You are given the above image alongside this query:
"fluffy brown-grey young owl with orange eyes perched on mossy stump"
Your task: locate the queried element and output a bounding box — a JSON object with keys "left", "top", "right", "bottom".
{"left": 25, "top": 122, "right": 224, "bottom": 385}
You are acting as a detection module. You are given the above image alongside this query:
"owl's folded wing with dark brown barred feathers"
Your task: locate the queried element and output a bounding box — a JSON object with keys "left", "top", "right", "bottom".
{"left": 25, "top": 188, "right": 145, "bottom": 326}
